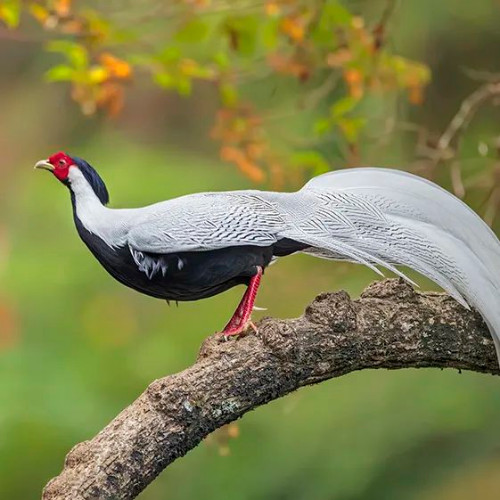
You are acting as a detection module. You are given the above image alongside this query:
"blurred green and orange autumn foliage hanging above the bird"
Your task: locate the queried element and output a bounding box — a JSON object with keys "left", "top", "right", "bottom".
{"left": 0, "top": 0, "right": 430, "bottom": 186}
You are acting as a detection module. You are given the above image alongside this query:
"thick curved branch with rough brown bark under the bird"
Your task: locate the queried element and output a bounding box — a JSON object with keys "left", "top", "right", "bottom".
{"left": 43, "top": 280, "right": 499, "bottom": 500}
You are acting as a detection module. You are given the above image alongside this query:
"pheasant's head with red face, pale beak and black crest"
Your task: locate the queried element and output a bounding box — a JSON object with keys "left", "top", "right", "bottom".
{"left": 35, "top": 151, "right": 109, "bottom": 205}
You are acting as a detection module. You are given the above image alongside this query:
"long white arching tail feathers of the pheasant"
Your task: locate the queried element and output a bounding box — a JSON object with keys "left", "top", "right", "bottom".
{"left": 283, "top": 168, "right": 500, "bottom": 354}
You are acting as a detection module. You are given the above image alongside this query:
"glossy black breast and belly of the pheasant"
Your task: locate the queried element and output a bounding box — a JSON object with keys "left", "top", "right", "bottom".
{"left": 75, "top": 216, "right": 304, "bottom": 301}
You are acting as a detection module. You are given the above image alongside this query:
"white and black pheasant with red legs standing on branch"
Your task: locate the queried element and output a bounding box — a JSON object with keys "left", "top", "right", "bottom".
{"left": 35, "top": 152, "right": 500, "bottom": 362}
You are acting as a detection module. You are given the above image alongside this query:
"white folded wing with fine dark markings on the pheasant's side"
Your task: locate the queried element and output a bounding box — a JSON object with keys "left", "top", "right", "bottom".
{"left": 128, "top": 191, "right": 286, "bottom": 254}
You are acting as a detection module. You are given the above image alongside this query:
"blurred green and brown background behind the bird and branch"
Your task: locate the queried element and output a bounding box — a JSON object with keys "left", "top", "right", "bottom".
{"left": 0, "top": 0, "right": 500, "bottom": 500}
